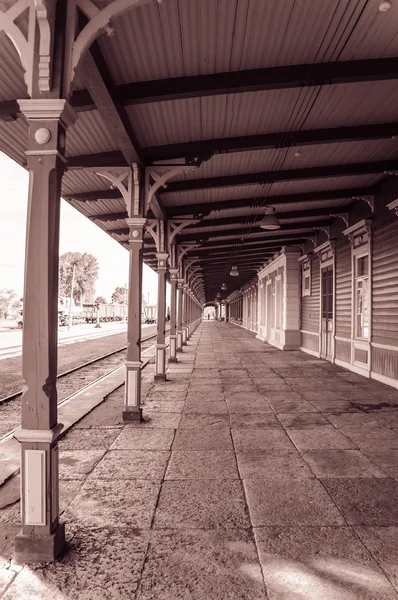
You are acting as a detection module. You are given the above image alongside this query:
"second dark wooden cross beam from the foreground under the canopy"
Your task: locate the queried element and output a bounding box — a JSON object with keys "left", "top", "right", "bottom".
{"left": 142, "top": 123, "right": 398, "bottom": 162}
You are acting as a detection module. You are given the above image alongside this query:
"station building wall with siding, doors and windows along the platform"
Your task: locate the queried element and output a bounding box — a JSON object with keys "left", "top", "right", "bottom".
{"left": 236, "top": 176, "right": 398, "bottom": 388}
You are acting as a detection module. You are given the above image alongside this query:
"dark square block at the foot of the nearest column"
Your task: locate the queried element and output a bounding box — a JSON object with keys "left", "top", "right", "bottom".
{"left": 14, "top": 523, "right": 65, "bottom": 564}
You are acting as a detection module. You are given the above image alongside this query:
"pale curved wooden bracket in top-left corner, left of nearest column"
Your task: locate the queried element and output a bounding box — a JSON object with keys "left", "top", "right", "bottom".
{"left": 0, "top": 0, "right": 56, "bottom": 96}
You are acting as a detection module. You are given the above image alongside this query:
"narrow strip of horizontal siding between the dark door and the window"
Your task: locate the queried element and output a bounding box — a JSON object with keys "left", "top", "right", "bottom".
{"left": 336, "top": 240, "right": 352, "bottom": 339}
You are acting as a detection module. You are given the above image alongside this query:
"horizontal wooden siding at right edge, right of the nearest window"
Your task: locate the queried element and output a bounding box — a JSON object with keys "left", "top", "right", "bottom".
{"left": 372, "top": 219, "right": 398, "bottom": 347}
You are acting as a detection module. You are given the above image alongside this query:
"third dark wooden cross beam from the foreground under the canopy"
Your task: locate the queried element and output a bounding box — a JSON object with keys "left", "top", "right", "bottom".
{"left": 162, "top": 160, "right": 398, "bottom": 195}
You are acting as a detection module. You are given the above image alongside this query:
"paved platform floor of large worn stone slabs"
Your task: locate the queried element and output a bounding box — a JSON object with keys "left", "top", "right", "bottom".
{"left": 0, "top": 322, "right": 398, "bottom": 600}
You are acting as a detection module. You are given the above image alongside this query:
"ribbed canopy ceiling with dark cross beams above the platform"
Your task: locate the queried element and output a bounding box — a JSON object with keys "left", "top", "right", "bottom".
{"left": 0, "top": 0, "right": 398, "bottom": 302}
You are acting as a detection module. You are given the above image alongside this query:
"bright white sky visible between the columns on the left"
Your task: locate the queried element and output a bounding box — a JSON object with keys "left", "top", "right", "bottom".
{"left": 0, "top": 152, "right": 162, "bottom": 304}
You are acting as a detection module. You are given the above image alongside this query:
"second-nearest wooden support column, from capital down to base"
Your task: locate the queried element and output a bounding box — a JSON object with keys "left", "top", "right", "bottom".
{"left": 123, "top": 217, "right": 146, "bottom": 421}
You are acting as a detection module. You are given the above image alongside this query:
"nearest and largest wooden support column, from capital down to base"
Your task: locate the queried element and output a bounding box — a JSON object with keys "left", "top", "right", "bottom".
{"left": 15, "top": 99, "right": 75, "bottom": 563}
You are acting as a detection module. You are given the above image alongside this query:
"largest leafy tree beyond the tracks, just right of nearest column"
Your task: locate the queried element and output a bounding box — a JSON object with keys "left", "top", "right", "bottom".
{"left": 59, "top": 252, "right": 99, "bottom": 304}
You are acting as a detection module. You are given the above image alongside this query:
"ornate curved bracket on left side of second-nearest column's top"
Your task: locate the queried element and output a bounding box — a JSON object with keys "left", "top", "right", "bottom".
{"left": 93, "top": 164, "right": 142, "bottom": 217}
